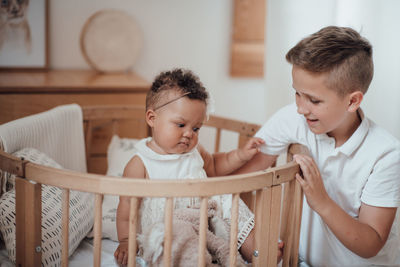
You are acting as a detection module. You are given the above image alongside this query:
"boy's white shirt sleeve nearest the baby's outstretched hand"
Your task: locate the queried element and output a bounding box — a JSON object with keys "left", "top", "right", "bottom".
{"left": 255, "top": 103, "right": 305, "bottom": 155}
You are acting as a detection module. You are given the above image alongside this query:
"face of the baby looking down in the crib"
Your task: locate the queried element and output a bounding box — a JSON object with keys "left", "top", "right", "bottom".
{"left": 146, "top": 93, "right": 206, "bottom": 154}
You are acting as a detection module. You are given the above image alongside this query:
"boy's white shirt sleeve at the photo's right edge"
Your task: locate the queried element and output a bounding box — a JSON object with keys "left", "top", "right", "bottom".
{"left": 361, "top": 146, "right": 400, "bottom": 207}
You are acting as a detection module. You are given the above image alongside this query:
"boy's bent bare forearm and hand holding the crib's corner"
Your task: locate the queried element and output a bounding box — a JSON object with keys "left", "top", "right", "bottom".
{"left": 294, "top": 155, "right": 397, "bottom": 258}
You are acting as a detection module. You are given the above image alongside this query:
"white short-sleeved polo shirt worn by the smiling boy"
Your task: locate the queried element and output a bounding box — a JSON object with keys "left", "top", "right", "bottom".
{"left": 256, "top": 103, "right": 400, "bottom": 266}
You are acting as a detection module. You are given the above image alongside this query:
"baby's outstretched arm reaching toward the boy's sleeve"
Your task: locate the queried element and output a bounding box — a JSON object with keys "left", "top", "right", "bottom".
{"left": 199, "top": 137, "right": 264, "bottom": 177}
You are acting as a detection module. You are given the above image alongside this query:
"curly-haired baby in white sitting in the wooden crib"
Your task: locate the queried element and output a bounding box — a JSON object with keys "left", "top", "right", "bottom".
{"left": 114, "top": 69, "right": 264, "bottom": 264}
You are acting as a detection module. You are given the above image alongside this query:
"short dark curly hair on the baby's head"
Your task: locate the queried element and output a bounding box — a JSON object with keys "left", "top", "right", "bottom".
{"left": 146, "top": 69, "right": 209, "bottom": 110}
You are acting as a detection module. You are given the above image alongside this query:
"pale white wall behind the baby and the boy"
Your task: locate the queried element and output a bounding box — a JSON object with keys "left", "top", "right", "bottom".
{"left": 50, "top": 0, "right": 400, "bottom": 141}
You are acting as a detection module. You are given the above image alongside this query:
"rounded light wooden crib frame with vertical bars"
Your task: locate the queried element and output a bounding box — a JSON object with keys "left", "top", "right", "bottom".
{"left": 0, "top": 106, "right": 304, "bottom": 266}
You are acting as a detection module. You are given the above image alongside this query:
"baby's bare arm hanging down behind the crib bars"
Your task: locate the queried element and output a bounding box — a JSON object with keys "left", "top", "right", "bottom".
{"left": 114, "top": 156, "right": 146, "bottom": 265}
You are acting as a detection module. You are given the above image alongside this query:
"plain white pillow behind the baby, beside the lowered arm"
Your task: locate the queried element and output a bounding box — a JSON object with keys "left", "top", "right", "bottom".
{"left": 102, "top": 135, "right": 139, "bottom": 241}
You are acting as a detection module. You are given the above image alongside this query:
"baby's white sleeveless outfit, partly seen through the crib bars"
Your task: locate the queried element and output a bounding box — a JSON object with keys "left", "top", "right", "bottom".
{"left": 135, "top": 137, "right": 254, "bottom": 247}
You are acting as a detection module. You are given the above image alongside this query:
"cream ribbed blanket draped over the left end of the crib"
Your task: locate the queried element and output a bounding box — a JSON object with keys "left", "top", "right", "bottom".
{"left": 0, "top": 104, "right": 86, "bottom": 172}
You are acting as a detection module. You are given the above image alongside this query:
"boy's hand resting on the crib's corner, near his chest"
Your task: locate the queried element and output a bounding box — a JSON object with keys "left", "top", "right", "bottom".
{"left": 293, "top": 154, "right": 330, "bottom": 213}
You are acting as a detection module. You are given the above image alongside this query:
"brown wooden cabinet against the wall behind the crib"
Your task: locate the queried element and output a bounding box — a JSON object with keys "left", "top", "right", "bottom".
{"left": 0, "top": 70, "right": 151, "bottom": 173}
